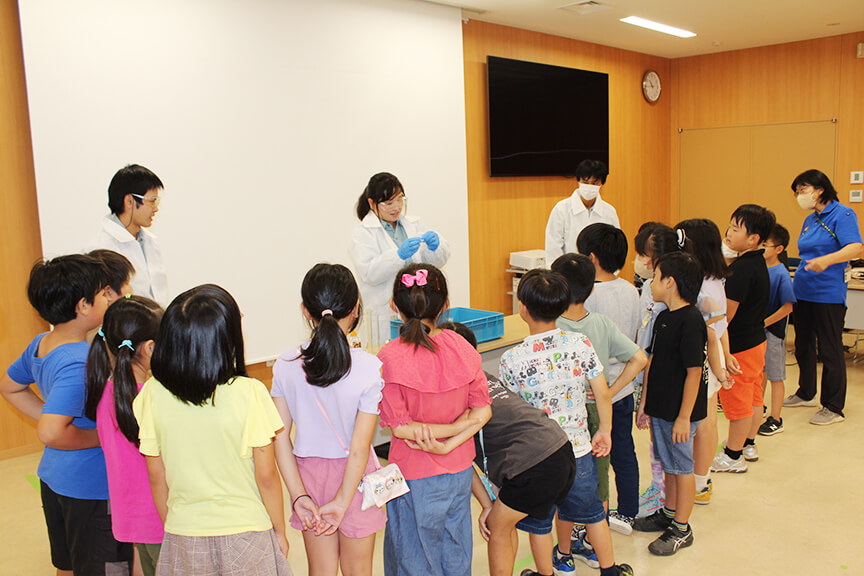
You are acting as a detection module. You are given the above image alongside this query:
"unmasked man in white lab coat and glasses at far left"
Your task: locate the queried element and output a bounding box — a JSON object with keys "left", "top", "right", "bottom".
{"left": 87, "top": 164, "right": 168, "bottom": 306}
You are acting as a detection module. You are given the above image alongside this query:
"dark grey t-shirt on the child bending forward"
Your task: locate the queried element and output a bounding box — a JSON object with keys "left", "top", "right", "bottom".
{"left": 474, "top": 373, "right": 570, "bottom": 486}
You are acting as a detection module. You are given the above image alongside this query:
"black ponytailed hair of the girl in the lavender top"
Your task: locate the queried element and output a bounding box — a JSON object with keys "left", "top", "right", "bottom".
{"left": 300, "top": 264, "right": 368, "bottom": 388}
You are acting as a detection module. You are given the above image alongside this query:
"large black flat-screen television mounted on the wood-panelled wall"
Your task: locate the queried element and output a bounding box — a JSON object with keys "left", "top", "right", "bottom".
{"left": 486, "top": 56, "right": 609, "bottom": 176}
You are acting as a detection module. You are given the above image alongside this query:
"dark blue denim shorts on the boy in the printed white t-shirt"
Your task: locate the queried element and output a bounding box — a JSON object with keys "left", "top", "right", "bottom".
{"left": 516, "top": 453, "right": 606, "bottom": 534}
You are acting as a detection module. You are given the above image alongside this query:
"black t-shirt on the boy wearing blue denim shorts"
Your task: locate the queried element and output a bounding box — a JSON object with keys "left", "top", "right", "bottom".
{"left": 645, "top": 305, "right": 708, "bottom": 422}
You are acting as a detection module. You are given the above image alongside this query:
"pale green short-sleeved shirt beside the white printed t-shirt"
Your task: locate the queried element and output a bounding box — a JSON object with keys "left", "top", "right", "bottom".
{"left": 555, "top": 312, "right": 639, "bottom": 403}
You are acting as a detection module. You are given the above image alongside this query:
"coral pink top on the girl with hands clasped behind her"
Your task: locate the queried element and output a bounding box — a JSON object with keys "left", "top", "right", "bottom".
{"left": 378, "top": 330, "right": 491, "bottom": 480}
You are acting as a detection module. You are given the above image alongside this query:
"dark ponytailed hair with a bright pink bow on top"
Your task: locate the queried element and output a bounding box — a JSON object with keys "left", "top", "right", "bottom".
{"left": 393, "top": 264, "right": 447, "bottom": 352}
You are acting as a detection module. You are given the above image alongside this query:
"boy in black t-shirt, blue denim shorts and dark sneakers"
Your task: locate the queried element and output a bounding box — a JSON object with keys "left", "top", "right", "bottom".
{"left": 633, "top": 252, "right": 708, "bottom": 556}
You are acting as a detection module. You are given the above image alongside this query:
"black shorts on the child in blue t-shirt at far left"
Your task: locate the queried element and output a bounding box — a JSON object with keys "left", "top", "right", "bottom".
{"left": 40, "top": 481, "right": 132, "bottom": 576}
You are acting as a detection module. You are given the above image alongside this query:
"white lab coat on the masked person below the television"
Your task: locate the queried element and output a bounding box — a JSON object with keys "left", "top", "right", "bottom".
{"left": 546, "top": 188, "right": 621, "bottom": 268}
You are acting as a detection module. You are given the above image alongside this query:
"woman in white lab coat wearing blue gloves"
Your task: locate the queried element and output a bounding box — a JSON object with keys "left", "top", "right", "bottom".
{"left": 350, "top": 172, "right": 450, "bottom": 346}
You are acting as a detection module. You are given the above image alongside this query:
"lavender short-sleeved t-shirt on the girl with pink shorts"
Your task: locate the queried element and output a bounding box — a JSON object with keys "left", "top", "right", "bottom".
{"left": 270, "top": 348, "right": 384, "bottom": 458}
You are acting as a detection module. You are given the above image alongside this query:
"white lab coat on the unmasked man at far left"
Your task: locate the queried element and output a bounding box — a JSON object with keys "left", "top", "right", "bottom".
{"left": 86, "top": 214, "right": 168, "bottom": 306}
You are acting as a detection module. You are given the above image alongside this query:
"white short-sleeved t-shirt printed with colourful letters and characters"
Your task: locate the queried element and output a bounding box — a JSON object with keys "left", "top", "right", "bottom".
{"left": 499, "top": 329, "right": 603, "bottom": 458}
